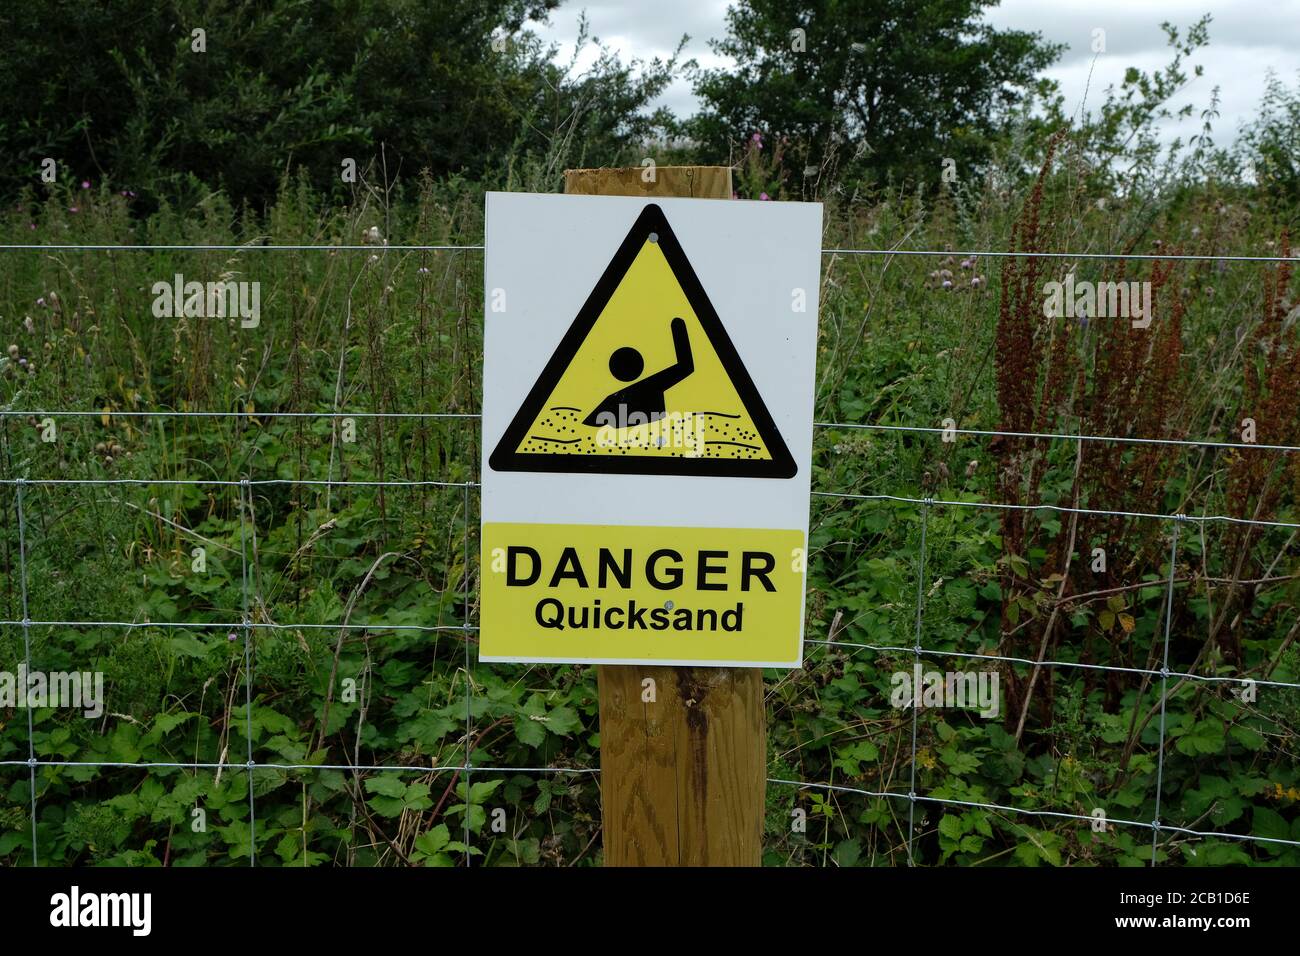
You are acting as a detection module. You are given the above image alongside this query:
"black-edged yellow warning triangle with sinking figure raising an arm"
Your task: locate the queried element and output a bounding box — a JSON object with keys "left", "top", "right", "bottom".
{"left": 488, "top": 203, "right": 796, "bottom": 479}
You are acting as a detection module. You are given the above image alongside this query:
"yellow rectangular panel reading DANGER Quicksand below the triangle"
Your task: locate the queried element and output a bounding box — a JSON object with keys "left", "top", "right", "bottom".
{"left": 482, "top": 523, "right": 803, "bottom": 667}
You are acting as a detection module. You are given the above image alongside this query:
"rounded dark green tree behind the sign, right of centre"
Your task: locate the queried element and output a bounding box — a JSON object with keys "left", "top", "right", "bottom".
{"left": 690, "top": 0, "right": 1062, "bottom": 195}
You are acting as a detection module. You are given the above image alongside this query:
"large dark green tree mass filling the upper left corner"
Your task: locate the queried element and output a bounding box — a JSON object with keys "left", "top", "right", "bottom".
{"left": 0, "top": 0, "right": 675, "bottom": 207}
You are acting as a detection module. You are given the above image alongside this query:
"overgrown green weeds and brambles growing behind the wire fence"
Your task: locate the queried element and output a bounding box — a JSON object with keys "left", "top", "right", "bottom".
{"left": 0, "top": 1, "right": 1300, "bottom": 866}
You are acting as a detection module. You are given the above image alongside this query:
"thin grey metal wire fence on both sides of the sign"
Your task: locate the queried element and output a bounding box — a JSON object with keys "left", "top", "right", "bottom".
{"left": 0, "top": 243, "right": 1300, "bottom": 866}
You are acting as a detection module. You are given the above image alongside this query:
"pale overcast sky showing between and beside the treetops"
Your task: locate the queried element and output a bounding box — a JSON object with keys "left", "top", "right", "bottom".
{"left": 527, "top": 0, "right": 1300, "bottom": 144}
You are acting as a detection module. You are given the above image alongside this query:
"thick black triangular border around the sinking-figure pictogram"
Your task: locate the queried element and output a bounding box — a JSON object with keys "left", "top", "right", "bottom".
{"left": 488, "top": 200, "right": 798, "bottom": 479}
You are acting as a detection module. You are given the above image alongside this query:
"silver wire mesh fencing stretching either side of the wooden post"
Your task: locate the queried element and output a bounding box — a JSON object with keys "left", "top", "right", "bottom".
{"left": 0, "top": 245, "right": 1300, "bottom": 865}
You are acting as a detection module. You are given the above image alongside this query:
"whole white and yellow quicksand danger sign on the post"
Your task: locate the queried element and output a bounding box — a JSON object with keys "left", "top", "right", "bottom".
{"left": 480, "top": 193, "right": 822, "bottom": 667}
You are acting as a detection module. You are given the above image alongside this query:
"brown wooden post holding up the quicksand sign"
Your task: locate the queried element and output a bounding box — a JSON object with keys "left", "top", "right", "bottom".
{"left": 564, "top": 166, "right": 767, "bottom": 866}
